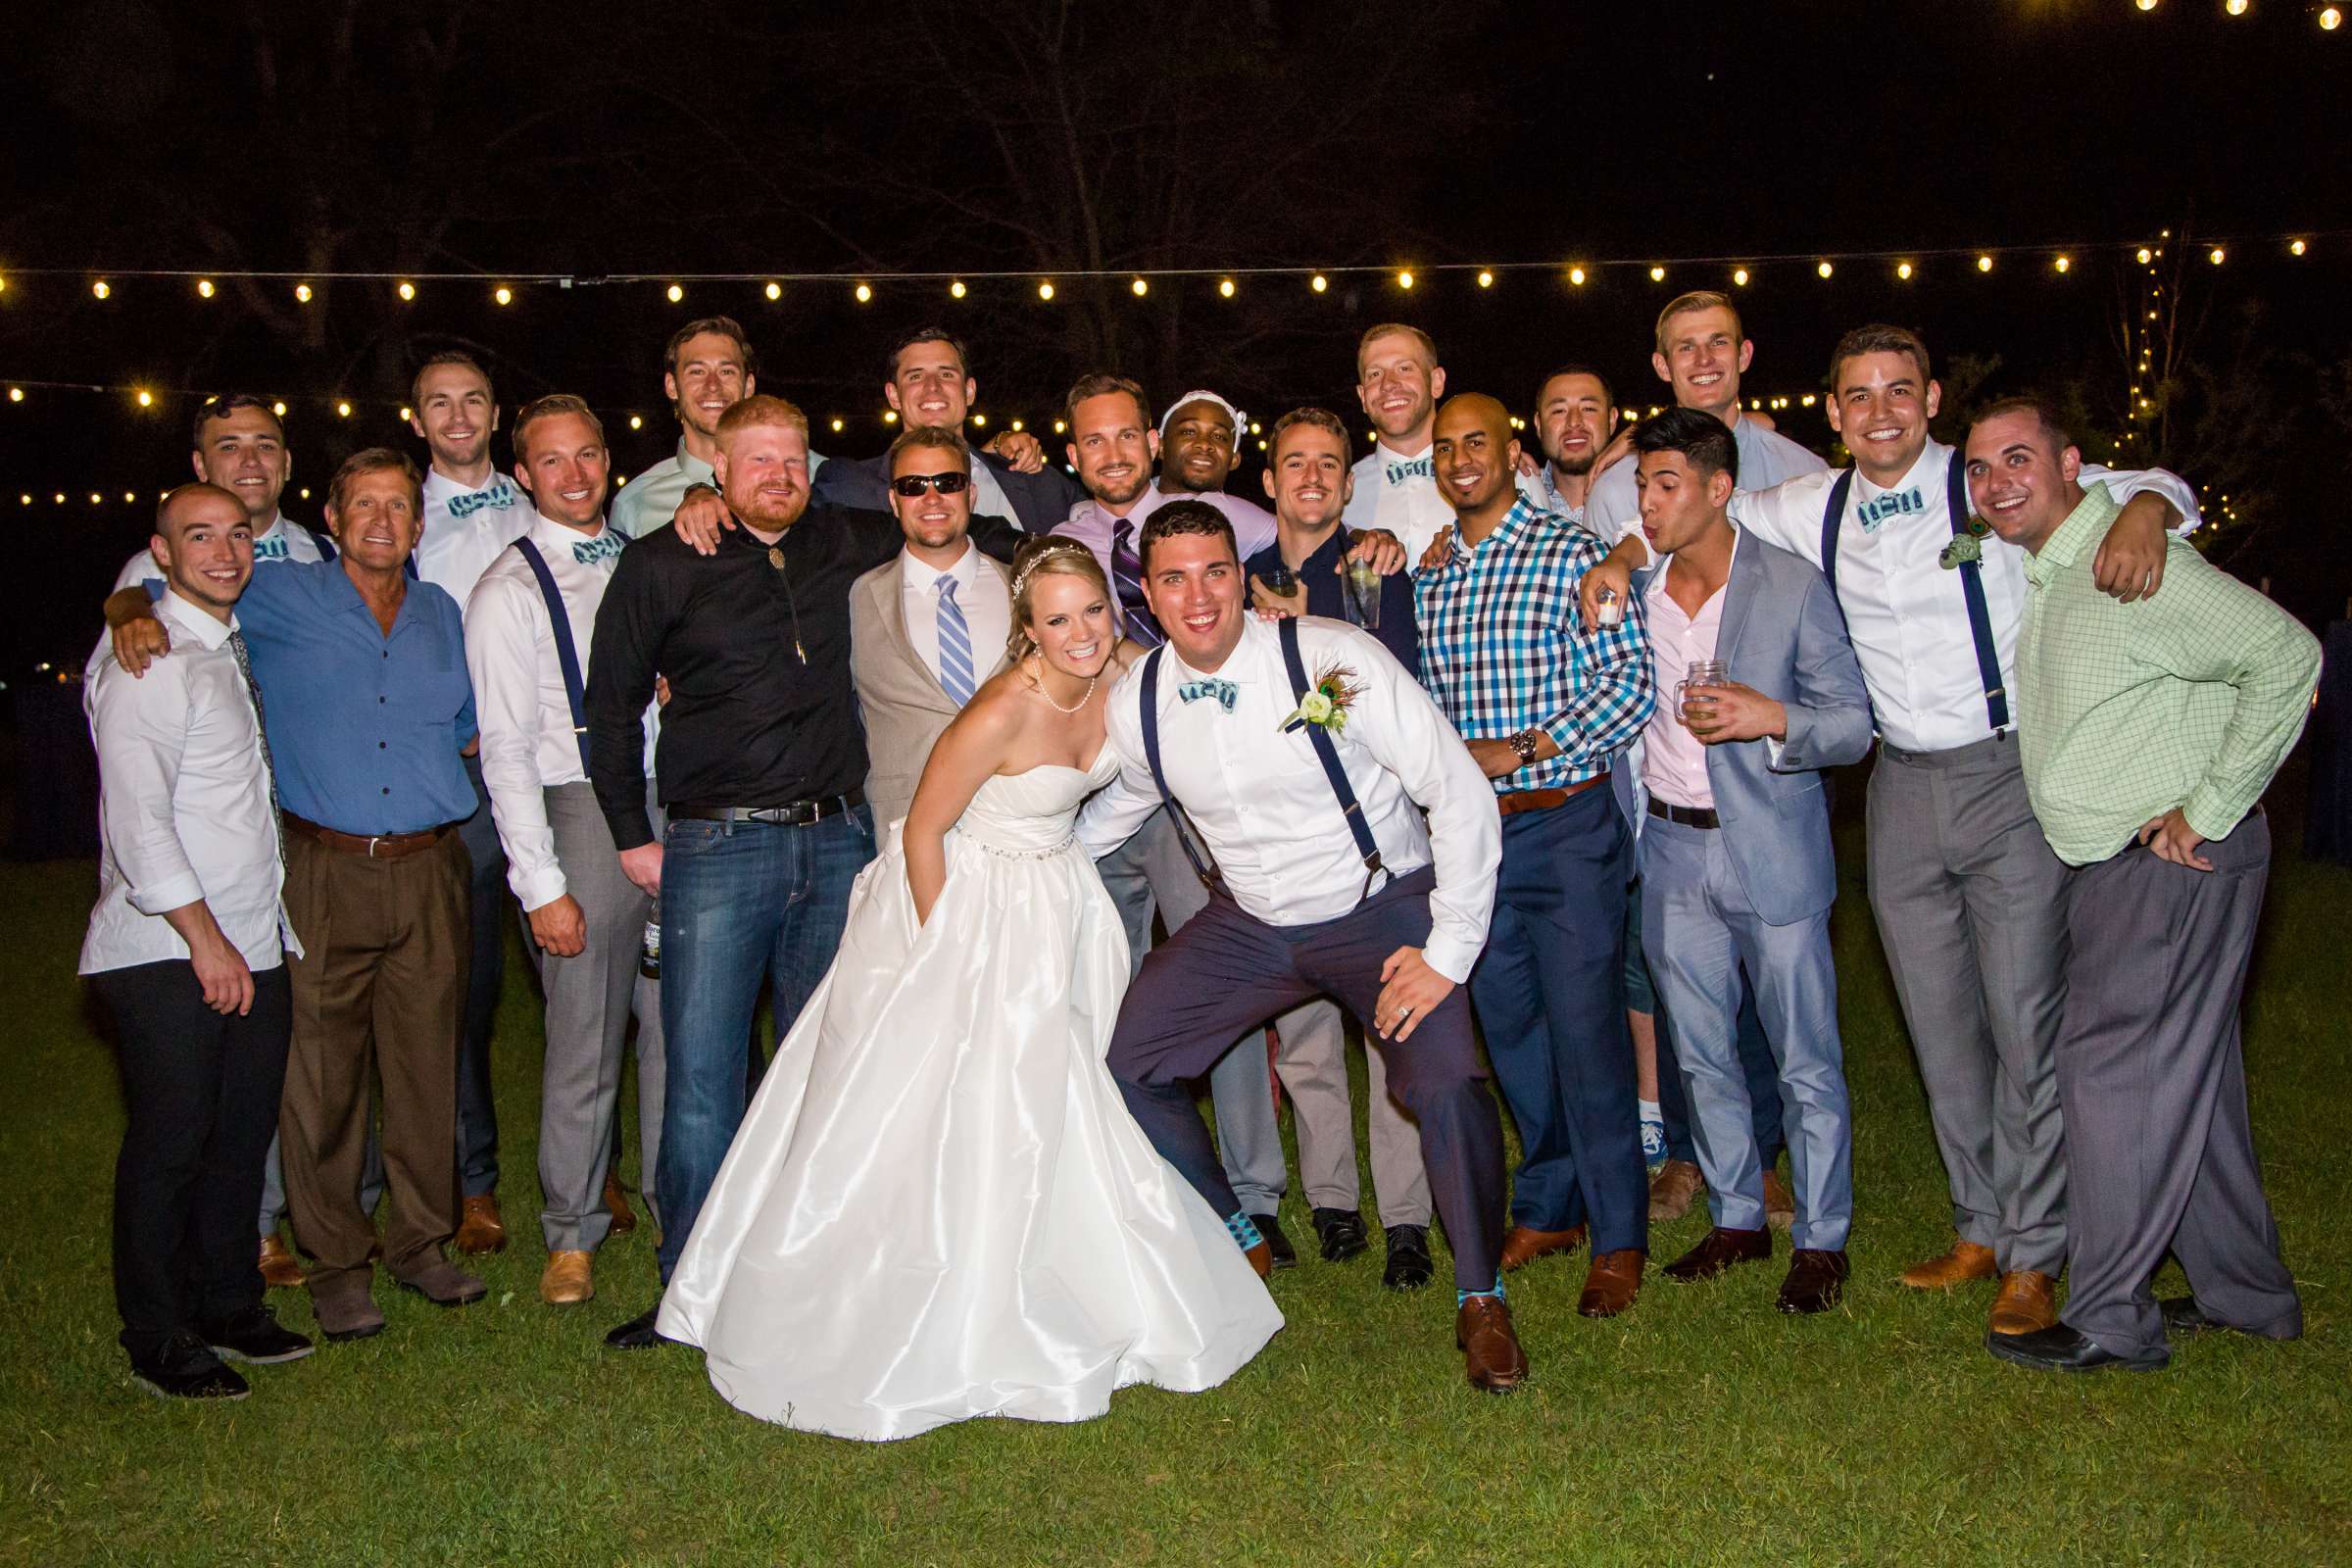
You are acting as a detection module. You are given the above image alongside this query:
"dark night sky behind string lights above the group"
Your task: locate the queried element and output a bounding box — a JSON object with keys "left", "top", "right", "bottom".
{"left": 0, "top": 0, "right": 2352, "bottom": 674}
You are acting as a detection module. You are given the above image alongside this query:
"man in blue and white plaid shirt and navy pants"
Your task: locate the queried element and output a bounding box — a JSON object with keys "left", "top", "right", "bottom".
{"left": 1413, "top": 395, "right": 1653, "bottom": 1316}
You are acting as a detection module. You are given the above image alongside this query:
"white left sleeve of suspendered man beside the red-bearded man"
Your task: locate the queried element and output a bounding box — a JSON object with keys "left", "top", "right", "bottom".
{"left": 466, "top": 571, "right": 569, "bottom": 909}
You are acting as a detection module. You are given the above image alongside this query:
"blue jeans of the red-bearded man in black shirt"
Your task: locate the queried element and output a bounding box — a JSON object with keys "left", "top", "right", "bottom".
{"left": 654, "top": 807, "right": 875, "bottom": 1281}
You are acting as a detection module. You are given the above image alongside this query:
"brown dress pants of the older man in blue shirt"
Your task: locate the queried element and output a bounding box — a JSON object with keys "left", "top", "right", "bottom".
{"left": 277, "top": 832, "right": 470, "bottom": 1293}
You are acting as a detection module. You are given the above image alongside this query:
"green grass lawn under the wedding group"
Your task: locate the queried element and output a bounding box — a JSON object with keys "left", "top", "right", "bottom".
{"left": 0, "top": 804, "right": 2352, "bottom": 1568}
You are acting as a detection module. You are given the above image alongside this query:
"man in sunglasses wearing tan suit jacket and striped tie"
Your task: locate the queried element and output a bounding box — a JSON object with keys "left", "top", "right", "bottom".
{"left": 849, "top": 425, "right": 1011, "bottom": 830}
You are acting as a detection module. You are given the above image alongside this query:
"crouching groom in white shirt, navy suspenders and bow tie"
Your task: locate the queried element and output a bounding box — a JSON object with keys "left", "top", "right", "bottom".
{"left": 1077, "top": 501, "right": 1527, "bottom": 1392}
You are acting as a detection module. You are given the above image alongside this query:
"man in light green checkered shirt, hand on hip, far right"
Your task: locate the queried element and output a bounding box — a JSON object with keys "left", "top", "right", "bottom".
{"left": 1966, "top": 397, "right": 2319, "bottom": 1373}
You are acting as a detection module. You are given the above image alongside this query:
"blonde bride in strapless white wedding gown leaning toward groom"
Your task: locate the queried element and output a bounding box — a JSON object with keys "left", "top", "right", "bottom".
{"left": 659, "top": 543, "right": 1282, "bottom": 1441}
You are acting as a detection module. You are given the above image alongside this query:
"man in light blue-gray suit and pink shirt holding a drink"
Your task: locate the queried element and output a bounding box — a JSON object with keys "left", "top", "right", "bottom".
{"left": 1621, "top": 409, "right": 1870, "bottom": 1312}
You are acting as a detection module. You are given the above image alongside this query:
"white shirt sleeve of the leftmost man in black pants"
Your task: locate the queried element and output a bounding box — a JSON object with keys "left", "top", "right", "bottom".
{"left": 89, "top": 659, "right": 205, "bottom": 914}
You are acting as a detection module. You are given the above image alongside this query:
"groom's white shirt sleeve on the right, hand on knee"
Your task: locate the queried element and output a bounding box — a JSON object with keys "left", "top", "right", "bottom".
{"left": 1348, "top": 632, "right": 1503, "bottom": 985}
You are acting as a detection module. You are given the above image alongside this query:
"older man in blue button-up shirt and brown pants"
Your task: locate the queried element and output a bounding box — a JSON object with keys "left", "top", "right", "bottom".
{"left": 106, "top": 447, "right": 482, "bottom": 1340}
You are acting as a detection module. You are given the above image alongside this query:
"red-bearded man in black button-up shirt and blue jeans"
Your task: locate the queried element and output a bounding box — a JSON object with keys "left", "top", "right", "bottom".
{"left": 588, "top": 397, "right": 1023, "bottom": 1349}
